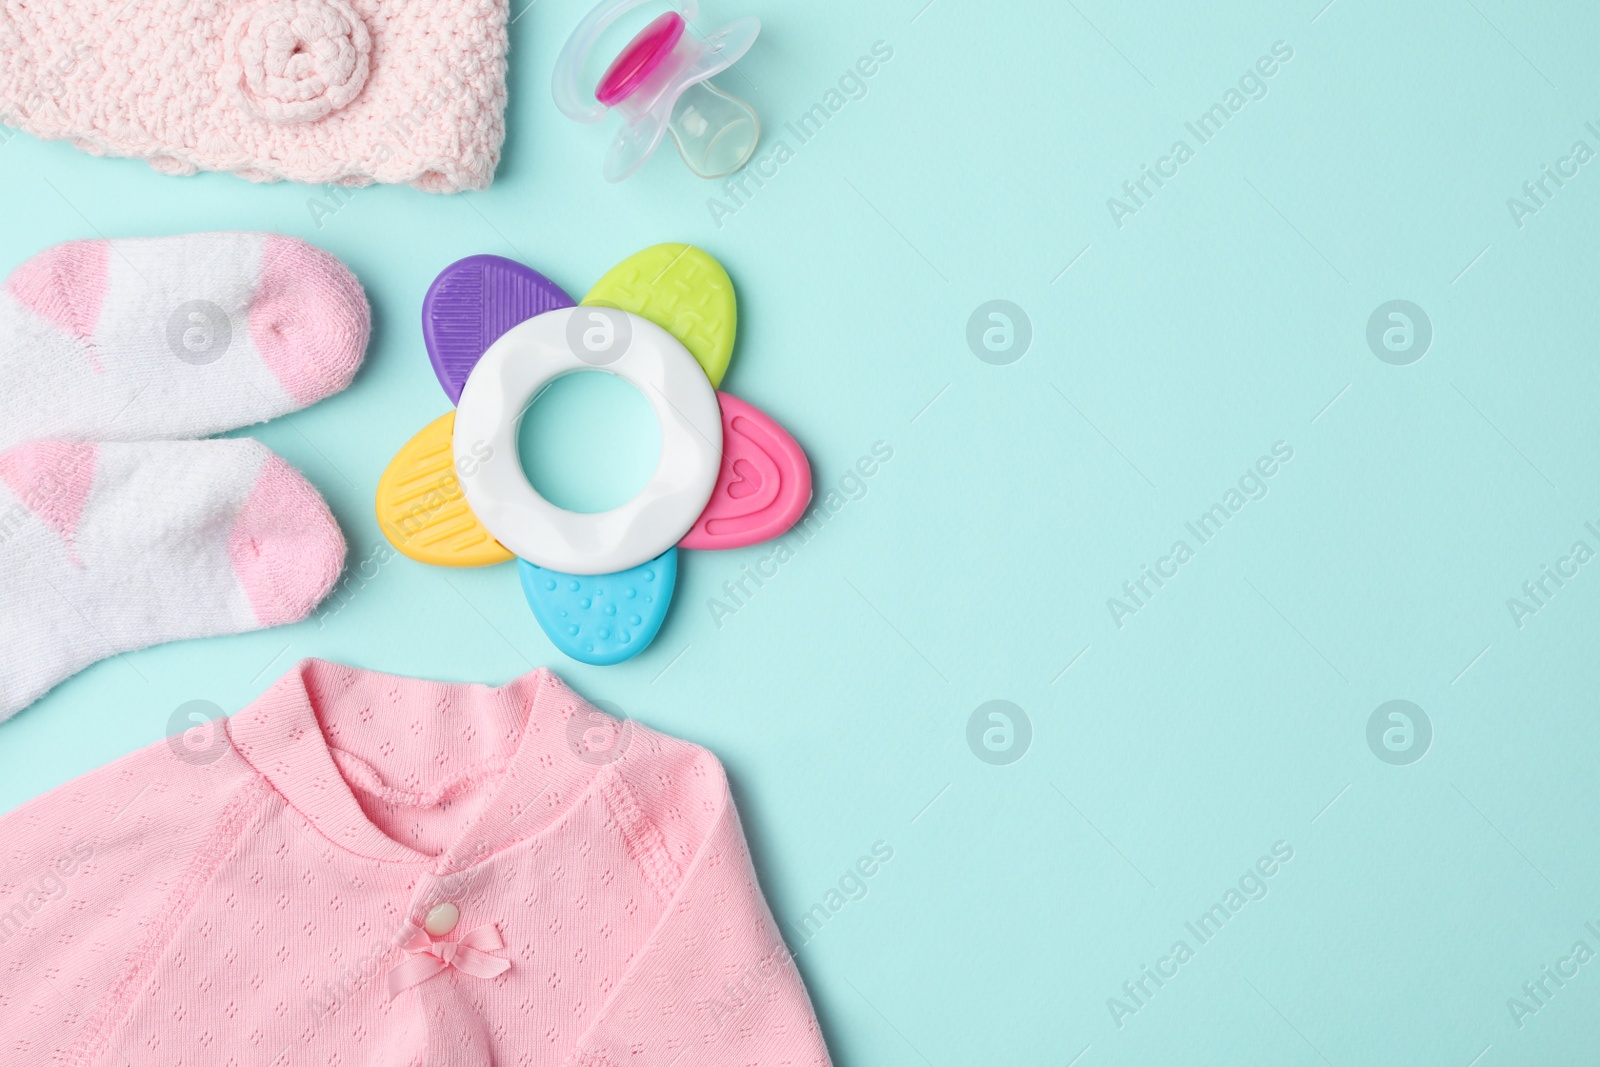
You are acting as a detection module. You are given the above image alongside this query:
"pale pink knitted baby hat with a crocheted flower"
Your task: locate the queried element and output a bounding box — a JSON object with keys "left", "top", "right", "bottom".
{"left": 0, "top": 0, "right": 507, "bottom": 192}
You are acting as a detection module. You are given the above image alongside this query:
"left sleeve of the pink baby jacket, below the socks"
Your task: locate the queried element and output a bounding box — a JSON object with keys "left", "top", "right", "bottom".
{"left": 0, "top": 741, "right": 262, "bottom": 1067}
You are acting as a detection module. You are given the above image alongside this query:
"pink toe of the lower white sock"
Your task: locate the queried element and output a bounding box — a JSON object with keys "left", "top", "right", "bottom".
{"left": 227, "top": 456, "right": 344, "bottom": 625}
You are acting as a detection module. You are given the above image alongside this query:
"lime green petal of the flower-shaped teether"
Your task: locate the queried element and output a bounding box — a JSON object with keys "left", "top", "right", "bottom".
{"left": 584, "top": 245, "right": 739, "bottom": 386}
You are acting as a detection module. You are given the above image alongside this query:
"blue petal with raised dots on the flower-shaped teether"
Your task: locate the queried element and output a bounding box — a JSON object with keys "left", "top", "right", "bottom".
{"left": 517, "top": 545, "right": 678, "bottom": 667}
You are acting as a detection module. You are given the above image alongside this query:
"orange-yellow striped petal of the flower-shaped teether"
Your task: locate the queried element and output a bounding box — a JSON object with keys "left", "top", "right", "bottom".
{"left": 378, "top": 411, "right": 515, "bottom": 566}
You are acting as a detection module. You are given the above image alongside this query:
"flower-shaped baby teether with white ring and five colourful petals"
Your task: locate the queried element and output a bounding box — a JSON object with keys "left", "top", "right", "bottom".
{"left": 378, "top": 245, "right": 811, "bottom": 665}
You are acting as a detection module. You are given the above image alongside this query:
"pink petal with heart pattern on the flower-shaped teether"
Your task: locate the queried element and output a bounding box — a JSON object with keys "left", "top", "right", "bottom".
{"left": 678, "top": 392, "right": 811, "bottom": 549}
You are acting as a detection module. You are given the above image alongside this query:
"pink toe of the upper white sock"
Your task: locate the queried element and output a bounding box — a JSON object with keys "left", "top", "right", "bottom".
{"left": 250, "top": 234, "right": 371, "bottom": 405}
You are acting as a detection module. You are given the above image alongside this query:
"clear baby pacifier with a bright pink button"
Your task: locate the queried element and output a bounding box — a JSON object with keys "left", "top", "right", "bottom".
{"left": 550, "top": 0, "right": 762, "bottom": 181}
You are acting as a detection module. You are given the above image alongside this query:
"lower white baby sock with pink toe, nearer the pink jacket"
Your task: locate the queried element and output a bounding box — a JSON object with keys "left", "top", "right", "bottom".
{"left": 0, "top": 438, "right": 344, "bottom": 720}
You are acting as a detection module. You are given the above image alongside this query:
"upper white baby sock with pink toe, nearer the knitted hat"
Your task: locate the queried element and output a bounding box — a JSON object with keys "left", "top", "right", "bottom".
{"left": 0, "top": 234, "right": 371, "bottom": 450}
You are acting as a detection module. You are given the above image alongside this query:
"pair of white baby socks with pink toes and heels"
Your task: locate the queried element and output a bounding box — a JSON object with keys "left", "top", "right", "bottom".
{"left": 0, "top": 234, "right": 371, "bottom": 720}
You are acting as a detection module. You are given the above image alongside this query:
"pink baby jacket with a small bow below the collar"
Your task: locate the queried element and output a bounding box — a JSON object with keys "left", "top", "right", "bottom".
{"left": 0, "top": 661, "right": 829, "bottom": 1067}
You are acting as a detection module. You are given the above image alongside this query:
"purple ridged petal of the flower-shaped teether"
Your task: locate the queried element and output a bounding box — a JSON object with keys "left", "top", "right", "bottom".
{"left": 422, "top": 256, "right": 573, "bottom": 403}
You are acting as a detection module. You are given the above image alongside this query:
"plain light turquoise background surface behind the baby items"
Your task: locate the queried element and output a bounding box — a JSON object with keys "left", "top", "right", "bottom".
{"left": 0, "top": 0, "right": 1600, "bottom": 1067}
